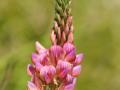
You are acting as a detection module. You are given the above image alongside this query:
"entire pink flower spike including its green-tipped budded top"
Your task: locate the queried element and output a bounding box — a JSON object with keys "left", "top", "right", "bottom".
{"left": 27, "top": 0, "right": 83, "bottom": 90}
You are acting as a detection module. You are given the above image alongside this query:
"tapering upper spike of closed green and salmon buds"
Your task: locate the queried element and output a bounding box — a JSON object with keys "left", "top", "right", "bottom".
{"left": 51, "top": 0, "right": 73, "bottom": 46}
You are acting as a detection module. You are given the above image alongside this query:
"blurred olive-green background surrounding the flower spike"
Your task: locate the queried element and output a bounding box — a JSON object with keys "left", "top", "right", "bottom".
{"left": 0, "top": 0, "right": 120, "bottom": 90}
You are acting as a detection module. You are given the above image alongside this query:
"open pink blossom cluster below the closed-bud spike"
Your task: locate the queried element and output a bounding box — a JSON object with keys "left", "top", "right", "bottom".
{"left": 27, "top": 42, "right": 83, "bottom": 90}
